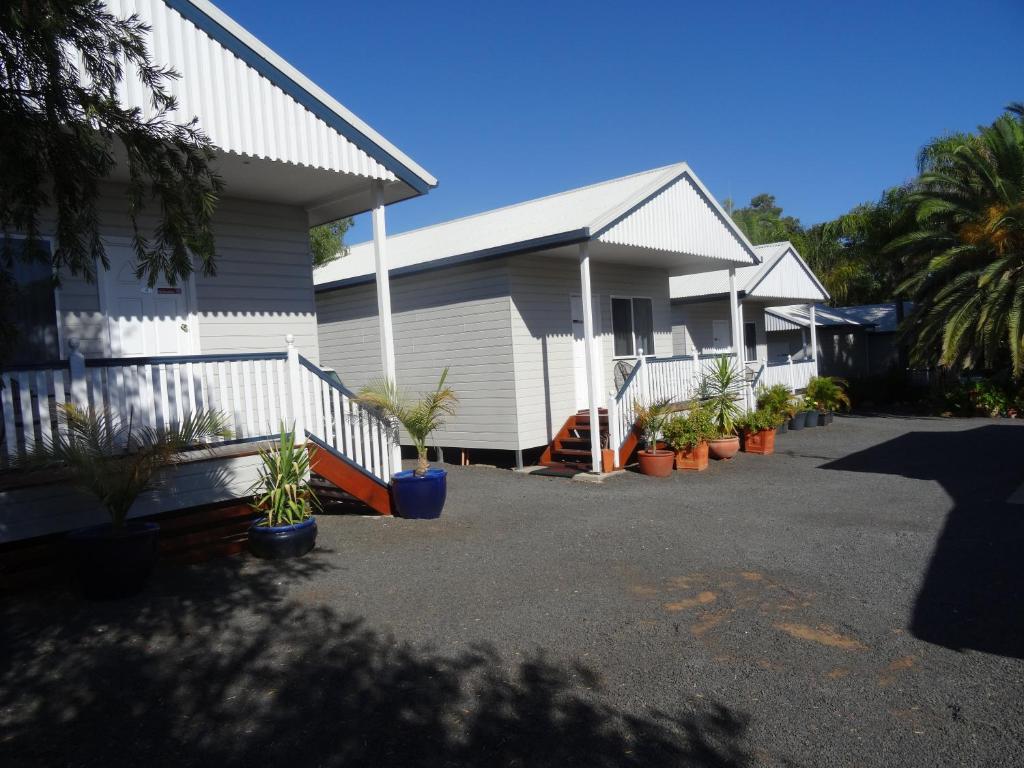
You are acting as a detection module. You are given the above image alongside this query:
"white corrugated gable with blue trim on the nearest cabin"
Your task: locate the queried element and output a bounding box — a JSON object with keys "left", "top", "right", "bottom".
{"left": 105, "top": 0, "right": 437, "bottom": 191}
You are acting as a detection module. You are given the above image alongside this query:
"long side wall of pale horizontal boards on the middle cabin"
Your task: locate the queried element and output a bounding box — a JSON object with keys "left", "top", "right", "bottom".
{"left": 316, "top": 259, "right": 518, "bottom": 451}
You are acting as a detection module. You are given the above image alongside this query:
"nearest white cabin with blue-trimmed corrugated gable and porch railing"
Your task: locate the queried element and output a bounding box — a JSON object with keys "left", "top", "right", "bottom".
{"left": 0, "top": 0, "right": 436, "bottom": 543}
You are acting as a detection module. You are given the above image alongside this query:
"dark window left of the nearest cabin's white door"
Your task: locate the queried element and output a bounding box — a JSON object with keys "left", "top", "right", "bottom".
{"left": 0, "top": 238, "right": 60, "bottom": 364}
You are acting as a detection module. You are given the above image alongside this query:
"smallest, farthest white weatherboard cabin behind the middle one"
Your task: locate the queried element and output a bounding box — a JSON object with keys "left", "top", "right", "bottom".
{"left": 671, "top": 242, "right": 828, "bottom": 397}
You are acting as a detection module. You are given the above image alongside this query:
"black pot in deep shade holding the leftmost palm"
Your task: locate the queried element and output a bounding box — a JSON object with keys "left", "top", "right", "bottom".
{"left": 68, "top": 522, "right": 160, "bottom": 600}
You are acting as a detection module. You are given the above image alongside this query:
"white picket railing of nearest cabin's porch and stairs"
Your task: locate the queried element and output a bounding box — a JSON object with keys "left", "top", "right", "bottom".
{"left": 0, "top": 336, "right": 399, "bottom": 482}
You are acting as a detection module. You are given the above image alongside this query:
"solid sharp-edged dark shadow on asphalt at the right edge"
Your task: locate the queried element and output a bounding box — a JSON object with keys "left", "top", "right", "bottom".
{"left": 822, "top": 424, "right": 1024, "bottom": 658}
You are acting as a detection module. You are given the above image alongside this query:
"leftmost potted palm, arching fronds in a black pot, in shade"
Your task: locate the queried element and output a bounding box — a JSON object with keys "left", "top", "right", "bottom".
{"left": 26, "top": 404, "right": 230, "bottom": 598}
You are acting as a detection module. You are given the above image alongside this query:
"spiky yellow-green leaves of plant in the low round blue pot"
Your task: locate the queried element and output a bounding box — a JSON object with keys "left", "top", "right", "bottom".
{"left": 249, "top": 424, "right": 319, "bottom": 526}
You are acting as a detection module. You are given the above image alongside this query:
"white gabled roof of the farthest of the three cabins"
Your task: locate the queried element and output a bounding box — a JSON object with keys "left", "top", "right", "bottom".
{"left": 669, "top": 241, "right": 828, "bottom": 302}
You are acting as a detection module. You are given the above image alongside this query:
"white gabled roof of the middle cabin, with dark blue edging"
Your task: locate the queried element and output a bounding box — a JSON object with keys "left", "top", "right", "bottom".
{"left": 314, "top": 163, "right": 757, "bottom": 290}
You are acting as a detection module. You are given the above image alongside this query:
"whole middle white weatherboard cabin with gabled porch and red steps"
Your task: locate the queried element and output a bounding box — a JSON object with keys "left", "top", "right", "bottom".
{"left": 314, "top": 163, "right": 759, "bottom": 464}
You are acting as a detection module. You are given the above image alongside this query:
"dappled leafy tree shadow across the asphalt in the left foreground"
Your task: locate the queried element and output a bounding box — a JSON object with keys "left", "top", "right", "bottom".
{"left": 0, "top": 557, "right": 748, "bottom": 768}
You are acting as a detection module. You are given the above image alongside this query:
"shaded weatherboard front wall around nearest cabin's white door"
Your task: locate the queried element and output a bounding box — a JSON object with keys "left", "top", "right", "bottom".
{"left": 54, "top": 185, "right": 318, "bottom": 360}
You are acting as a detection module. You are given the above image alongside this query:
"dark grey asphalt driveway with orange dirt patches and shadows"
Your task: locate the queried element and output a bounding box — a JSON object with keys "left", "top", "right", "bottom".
{"left": 0, "top": 417, "right": 1024, "bottom": 766}
